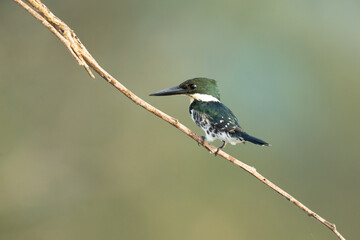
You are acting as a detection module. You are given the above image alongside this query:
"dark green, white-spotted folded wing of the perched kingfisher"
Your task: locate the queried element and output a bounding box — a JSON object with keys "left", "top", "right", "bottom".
{"left": 194, "top": 102, "right": 244, "bottom": 133}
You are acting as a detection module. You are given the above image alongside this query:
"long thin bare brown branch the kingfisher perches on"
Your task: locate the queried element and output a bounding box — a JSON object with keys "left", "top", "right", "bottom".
{"left": 13, "top": 0, "right": 345, "bottom": 240}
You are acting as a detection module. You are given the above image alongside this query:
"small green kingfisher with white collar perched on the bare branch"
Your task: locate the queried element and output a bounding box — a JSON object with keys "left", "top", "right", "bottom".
{"left": 150, "top": 78, "right": 270, "bottom": 155}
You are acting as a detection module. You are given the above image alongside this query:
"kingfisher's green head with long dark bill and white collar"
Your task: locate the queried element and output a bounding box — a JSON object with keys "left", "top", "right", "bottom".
{"left": 150, "top": 78, "right": 220, "bottom": 102}
